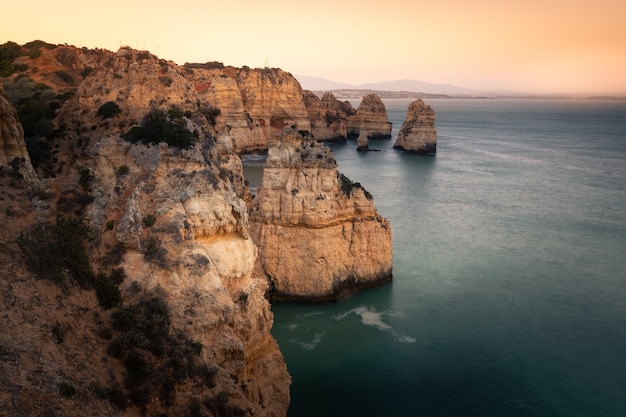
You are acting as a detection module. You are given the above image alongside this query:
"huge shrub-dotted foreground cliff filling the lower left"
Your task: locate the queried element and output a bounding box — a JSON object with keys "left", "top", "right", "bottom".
{"left": 0, "top": 44, "right": 290, "bottom": 416}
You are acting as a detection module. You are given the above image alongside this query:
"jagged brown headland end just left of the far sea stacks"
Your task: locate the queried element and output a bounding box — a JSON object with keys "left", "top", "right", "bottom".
{"left": 303, "top": 91, "right": 354, "bottom": 142}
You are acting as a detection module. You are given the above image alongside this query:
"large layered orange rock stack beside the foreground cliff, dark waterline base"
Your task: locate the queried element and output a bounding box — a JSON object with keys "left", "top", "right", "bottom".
{"left": 250, "top": 129, "right": 392, "bottom": 302}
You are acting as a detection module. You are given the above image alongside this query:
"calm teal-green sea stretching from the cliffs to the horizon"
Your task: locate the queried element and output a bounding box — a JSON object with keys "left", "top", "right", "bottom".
{"left": 246, "top": 99, "right": 626, "bottom": 417}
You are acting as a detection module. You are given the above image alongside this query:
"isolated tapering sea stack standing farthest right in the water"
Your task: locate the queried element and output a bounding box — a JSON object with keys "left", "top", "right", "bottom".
{"left": 393, "top": 99, "right": 437, "bottom": 154}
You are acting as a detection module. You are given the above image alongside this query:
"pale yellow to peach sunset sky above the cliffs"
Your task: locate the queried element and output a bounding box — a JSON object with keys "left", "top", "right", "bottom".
{"left": 0, "top": 0, "right": 626, "bottom": 93}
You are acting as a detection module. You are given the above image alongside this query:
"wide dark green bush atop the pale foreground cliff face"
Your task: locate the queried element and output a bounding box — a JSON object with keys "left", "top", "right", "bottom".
{"left": 122, "top": 109, "right": 196, "bottom": 149}
